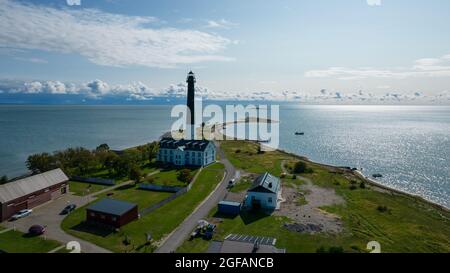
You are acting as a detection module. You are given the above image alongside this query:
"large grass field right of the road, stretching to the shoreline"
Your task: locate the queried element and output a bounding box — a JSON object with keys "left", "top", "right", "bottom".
{"left": 178, "top": 141, "right": 450, "bottom": 253}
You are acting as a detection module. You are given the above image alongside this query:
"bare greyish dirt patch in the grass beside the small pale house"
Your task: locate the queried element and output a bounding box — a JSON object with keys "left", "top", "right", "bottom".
{"left": 275, "top": 178, "right": 345, "bottom": 233}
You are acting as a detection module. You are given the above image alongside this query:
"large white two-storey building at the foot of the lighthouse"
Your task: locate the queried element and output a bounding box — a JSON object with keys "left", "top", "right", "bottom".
{"left": 157, "top": 137, "right": 216, "bottom": 167}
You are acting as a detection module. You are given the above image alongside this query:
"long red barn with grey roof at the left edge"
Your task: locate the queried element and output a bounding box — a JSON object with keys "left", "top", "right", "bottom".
{"left": 0, "top": 169, "right": 69, "bottom": 221}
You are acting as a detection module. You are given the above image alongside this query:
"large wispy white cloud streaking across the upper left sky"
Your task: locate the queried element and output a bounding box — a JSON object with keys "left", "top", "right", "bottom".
{"left": 0, "top": 0, "right": 233, "bottom": 67}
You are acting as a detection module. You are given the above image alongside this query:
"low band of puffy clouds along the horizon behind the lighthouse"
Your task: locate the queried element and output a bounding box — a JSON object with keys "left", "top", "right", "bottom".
{"left": 0, "top": 79, "right": 450, "bottom": 104}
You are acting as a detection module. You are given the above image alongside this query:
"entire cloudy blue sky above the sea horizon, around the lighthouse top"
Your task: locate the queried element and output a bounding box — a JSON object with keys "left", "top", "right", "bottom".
{"left": 0, "top": 0, "right": 450, "bottom": 104}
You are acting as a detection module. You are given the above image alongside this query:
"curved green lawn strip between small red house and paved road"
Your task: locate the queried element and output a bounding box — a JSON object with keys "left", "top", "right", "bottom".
{"left": 62, "top": 163, "right": 224, "bottom": 252}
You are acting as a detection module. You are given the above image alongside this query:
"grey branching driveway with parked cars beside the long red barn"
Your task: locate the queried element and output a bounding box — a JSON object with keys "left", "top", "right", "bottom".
{"left": 2, "top": 194, "right": 110, "bottom": 253}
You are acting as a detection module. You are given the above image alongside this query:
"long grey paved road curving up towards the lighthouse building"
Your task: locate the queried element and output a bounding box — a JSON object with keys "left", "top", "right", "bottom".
{"left": 155, "top": 143, "right": 236, "bottom": 253}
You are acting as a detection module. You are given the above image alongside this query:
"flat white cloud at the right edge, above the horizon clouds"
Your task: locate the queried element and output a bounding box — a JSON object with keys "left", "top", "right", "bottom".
{"left": 305, "top": 55, "right": 450, "bottom": 80}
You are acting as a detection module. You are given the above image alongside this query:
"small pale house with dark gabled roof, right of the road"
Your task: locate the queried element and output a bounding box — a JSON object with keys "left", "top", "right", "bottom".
{"left": 245, "top": 173, "right": 281, "bottom": 210}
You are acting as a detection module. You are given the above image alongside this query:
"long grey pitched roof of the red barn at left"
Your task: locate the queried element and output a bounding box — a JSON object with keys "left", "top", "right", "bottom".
{"left": 0, "top": 169, "right": 69, "bottom": 203}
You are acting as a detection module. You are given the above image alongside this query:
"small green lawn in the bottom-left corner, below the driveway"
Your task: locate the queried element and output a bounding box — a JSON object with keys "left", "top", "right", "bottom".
{"left": 0, "top": 230, "right": 61, "bottom": 253}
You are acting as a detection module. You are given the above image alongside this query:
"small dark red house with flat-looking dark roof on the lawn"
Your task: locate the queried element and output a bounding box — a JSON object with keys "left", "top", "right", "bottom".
{"left": 86, "top": 198, "right": 139, "bottom": 228}
